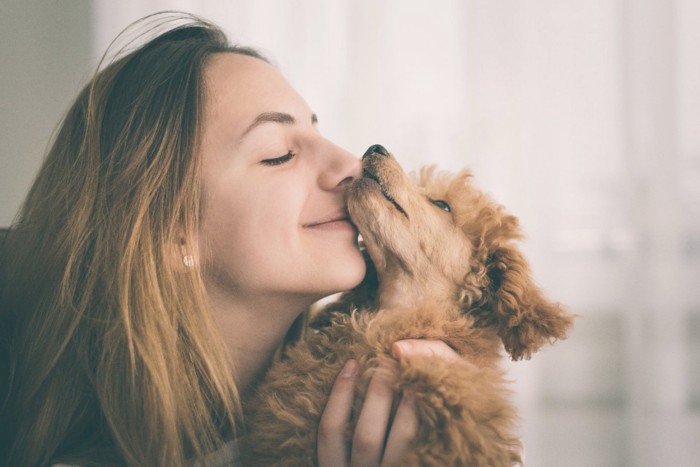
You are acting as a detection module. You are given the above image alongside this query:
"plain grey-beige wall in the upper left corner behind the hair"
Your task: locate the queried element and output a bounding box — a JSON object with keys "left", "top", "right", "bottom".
{"left": 0, "top": 0, "right": 94, "bottom": 227}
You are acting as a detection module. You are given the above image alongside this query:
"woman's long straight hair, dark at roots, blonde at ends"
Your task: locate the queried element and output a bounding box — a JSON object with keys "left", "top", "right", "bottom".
{"left": 0, "top": 14, "right": 262, "bottom": 466}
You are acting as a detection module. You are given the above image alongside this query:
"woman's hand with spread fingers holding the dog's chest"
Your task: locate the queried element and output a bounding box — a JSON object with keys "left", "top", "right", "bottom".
{"left": 317, "top": 339, "right": 461, "bottom": 467}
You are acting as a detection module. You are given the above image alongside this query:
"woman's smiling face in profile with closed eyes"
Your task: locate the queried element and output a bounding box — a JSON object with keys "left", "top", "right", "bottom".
{"left": 198, "top": 53, "right": 365, "bottom": 308}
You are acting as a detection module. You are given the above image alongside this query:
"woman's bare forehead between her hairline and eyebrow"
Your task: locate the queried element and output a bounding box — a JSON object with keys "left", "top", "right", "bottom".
{"left": 204, "top": 52, "right": 308, "bottom": 125}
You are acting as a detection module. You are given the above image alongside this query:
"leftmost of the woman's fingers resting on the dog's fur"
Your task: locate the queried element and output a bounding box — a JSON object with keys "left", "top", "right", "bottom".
{"left": 316, "top": 360, "right": 357, "bottom": 466}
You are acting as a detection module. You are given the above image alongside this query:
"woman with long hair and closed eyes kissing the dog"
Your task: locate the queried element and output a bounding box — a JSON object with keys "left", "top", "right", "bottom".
{"left": 0, "top": 15, "right": 455, "bottom": 466}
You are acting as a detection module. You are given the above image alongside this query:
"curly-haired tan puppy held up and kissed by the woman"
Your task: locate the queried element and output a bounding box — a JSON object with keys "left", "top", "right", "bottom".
{"left": 245, "top": 145, "right": 572, "bottom": 467}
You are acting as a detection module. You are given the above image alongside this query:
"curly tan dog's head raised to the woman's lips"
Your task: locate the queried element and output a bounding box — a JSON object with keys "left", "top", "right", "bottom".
{"left": 348, "top": 145, "right": 572, "bottom": 360}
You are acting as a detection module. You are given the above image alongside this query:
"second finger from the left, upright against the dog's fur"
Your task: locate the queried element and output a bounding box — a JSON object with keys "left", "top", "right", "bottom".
{"left": 350, "top": 366, "right": 396, "bottom": 467}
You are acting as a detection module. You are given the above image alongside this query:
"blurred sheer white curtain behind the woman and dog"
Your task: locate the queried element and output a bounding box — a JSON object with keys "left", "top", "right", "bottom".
{"left": 95, "top": 0, "right": 700, "bottom": 467}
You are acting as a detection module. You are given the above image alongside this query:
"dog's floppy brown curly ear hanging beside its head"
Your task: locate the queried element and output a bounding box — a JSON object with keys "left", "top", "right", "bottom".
{"left": 486, "top": 245, "right": 573, "bottom": 360}
